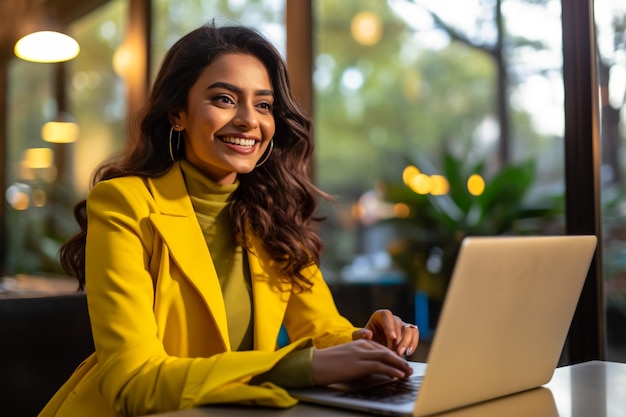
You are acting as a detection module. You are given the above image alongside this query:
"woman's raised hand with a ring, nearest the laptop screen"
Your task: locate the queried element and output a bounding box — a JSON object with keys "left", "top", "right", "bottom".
{"left": 352, "top": 309, "right": 419, "bottom": 356}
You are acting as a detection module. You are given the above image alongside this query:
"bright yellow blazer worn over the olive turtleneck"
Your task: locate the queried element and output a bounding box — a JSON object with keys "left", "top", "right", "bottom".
{"left": 40, "top": 164, "right": 355, "bottom": 417}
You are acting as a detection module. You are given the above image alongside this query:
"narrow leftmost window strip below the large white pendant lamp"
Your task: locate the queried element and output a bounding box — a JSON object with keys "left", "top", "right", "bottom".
{"left": 3, "top": 58, "right": 56, "bottom": 274}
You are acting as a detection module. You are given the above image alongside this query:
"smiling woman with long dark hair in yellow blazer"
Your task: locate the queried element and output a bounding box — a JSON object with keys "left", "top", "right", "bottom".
{"left": 40, "top": 26, "right": 418, "bottom": 416}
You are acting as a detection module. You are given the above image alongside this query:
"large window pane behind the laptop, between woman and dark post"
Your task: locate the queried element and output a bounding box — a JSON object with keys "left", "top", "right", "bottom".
{"left": 314, "top": 0, "right": 564, "bottom": 335}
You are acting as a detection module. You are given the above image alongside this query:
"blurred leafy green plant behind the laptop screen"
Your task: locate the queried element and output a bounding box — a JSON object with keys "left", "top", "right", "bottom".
{"left": 383, "top": 152, "right": 563, "bottom": 301}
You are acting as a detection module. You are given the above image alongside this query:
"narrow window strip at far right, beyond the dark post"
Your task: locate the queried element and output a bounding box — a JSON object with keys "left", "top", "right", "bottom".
{"left": 595, "top": 0, "right": 626, "bottom": 362}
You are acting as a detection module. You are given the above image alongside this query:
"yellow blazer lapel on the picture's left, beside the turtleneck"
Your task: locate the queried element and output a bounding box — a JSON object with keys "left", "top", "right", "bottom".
{"left": 149, "top": 164, "right": 231, "bottom": 351}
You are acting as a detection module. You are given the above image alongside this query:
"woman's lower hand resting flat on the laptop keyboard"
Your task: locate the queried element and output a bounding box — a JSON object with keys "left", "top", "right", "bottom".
{"left": 312, "top": 338, "right": 413, "bottom": 385}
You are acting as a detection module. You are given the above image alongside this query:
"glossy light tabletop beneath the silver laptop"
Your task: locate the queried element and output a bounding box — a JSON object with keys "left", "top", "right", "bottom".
{"left": 143, "top": 361, "right": 626, "bottom": 417}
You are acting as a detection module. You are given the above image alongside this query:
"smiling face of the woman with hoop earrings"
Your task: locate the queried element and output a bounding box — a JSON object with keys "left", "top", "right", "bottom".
{"left": 176, "top": 53, "right": 275, "bottom": 184}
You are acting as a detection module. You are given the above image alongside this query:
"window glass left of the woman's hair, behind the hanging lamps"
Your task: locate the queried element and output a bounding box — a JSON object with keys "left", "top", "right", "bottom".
{"left": 5, "top": 0, "right": 126, "bottom": 275}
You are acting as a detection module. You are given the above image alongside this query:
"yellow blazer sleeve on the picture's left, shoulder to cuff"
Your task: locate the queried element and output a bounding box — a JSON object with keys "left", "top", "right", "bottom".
{"left": 86, "top": 178, "right": 312, "bottom": 415}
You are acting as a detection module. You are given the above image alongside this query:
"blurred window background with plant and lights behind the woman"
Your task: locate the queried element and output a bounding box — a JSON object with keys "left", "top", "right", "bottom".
{"left": 0, "top": 0, "right": 626, "bottom": 361}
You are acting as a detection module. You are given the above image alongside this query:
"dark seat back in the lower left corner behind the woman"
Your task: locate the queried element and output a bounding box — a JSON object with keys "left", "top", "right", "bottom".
{"left": 0, "top": 294, "right": 94, "bottom": 417}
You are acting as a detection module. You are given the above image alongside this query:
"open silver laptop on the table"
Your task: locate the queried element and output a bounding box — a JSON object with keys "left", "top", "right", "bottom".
{"left": 290, "top": 236, "right": 597, "bottom": 417}
